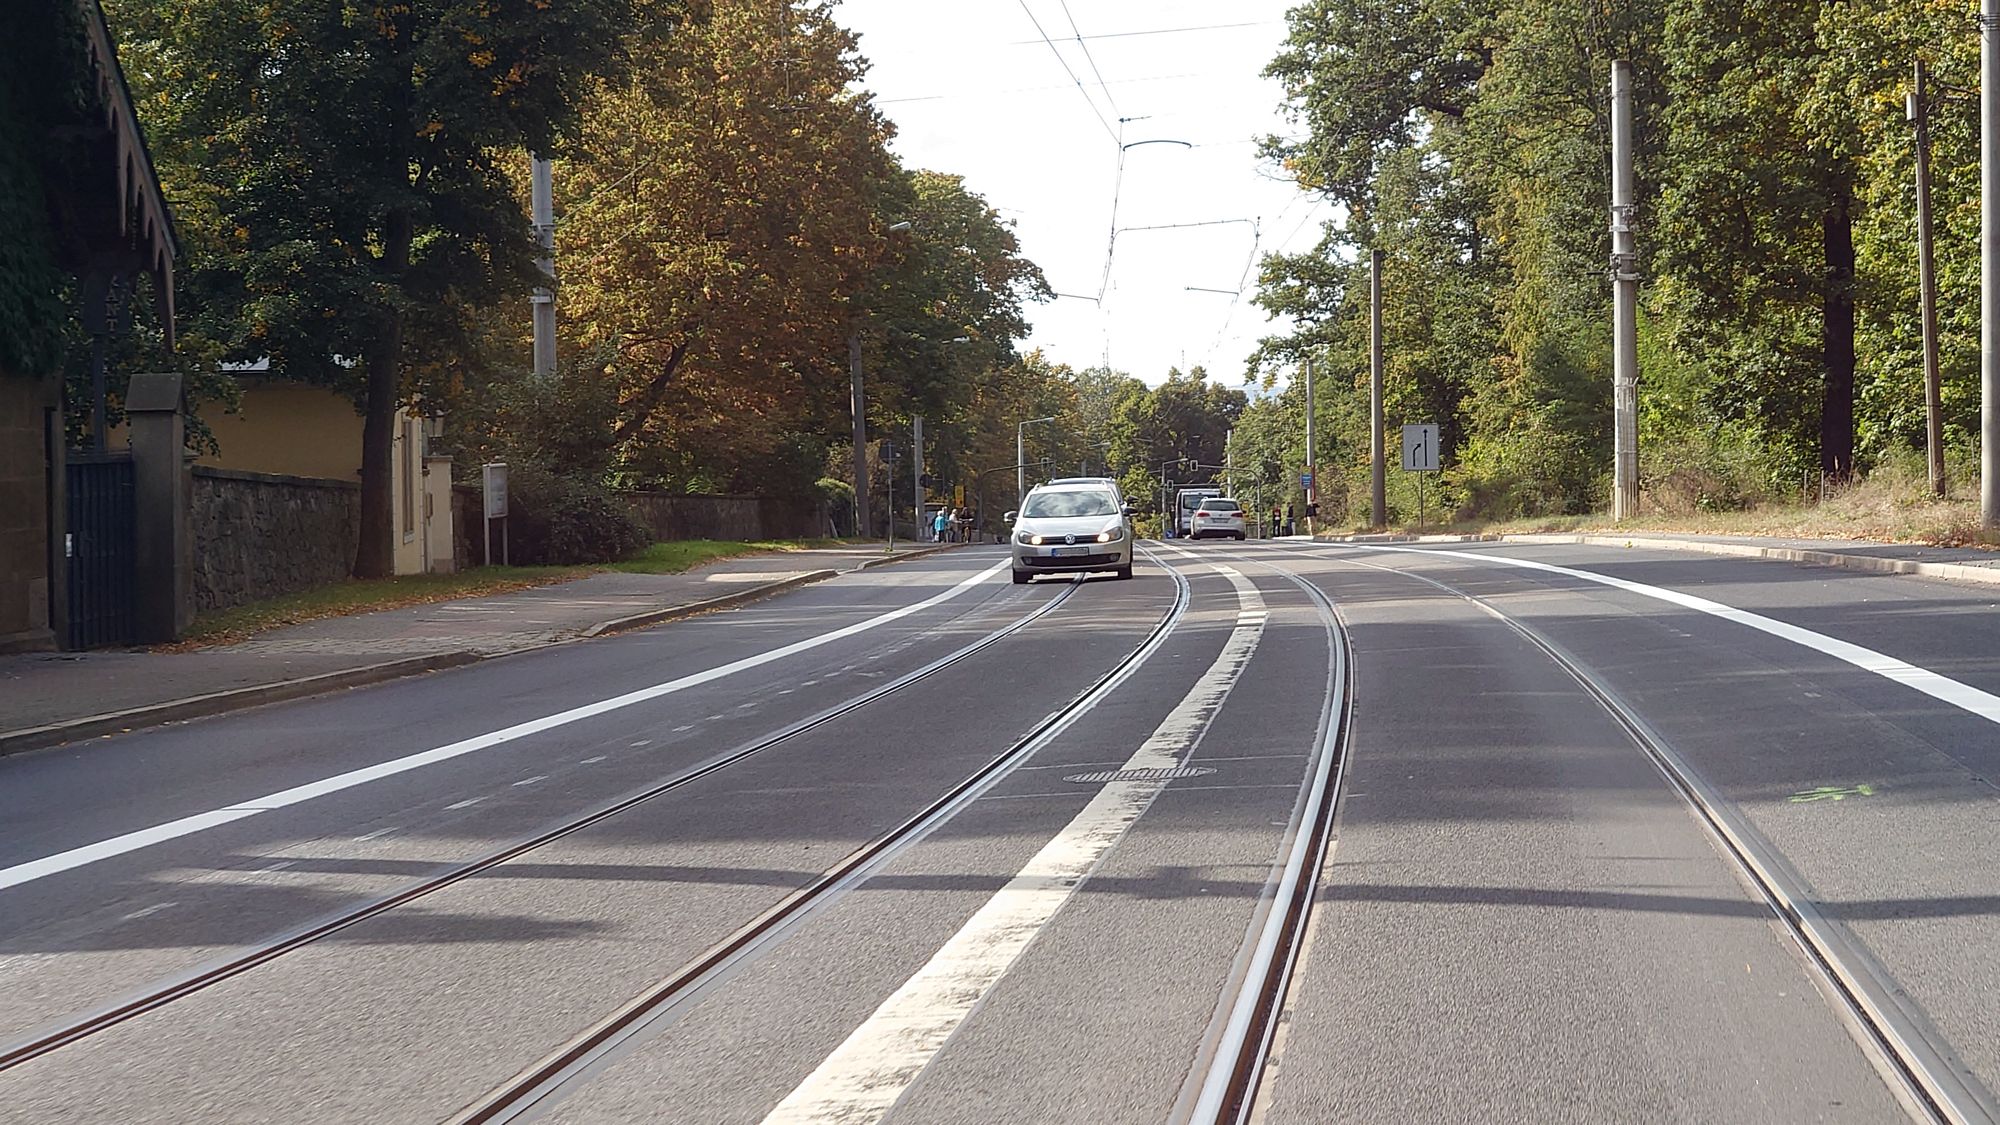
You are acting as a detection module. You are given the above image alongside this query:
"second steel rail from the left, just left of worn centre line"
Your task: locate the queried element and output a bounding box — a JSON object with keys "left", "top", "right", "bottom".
{"left": 450, "top": 558, "right": 1190, "bottom": 1125}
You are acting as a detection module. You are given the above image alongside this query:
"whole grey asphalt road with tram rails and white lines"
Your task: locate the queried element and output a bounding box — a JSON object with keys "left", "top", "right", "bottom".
{"left": 0, "top": 542, "right": 2000, "bottom": 1125}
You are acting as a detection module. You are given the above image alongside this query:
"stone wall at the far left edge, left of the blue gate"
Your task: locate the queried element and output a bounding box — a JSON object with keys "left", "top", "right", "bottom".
{"left": 0, "top": 370, "right": 54, "bottom": 653}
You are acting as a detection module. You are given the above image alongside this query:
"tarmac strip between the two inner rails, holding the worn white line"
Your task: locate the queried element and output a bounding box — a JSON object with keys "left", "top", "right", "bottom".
{"left": 524, "top": 550, "right": 1330, "bottom": 1125}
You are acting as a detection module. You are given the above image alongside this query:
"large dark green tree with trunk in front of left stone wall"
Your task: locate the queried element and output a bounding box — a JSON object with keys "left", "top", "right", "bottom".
{"left": 106, "top": 0, "right": 632, "bottom": 577}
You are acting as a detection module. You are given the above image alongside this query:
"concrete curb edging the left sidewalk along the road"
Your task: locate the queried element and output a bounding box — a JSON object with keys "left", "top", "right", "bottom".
{"left": 0, "top": 571, "right": 860, "bottom": 757}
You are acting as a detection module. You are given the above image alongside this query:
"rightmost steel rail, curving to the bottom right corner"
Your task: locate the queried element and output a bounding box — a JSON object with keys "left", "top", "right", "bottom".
{"left": 1302, "top": 550, "right": 2000, "bottom": 1125}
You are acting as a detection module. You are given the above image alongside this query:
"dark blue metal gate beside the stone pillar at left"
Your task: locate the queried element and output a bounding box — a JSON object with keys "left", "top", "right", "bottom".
{"left": 64, "top": 452, "right": 136, "bottom": 649}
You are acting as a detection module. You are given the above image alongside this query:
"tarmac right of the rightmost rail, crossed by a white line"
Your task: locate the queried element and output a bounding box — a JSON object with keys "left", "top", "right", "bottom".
{"left": 1272, "top": 546, "right": 2000, "bottom": 1115}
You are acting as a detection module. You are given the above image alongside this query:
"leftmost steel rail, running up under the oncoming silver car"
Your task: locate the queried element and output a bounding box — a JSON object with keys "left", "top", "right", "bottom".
{"left": 0, "top": 583, "right": 1080, "bottom": 1071}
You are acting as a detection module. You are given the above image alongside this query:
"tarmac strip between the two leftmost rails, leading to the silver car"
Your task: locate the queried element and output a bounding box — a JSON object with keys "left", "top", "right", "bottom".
{"left": 0, "top": 552, "right": 1170, "bottom": 1121}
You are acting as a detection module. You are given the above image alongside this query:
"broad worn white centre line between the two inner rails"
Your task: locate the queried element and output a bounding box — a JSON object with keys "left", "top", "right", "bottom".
{"left": 764, "top": 567, "right": 1264, "bottom": 1125}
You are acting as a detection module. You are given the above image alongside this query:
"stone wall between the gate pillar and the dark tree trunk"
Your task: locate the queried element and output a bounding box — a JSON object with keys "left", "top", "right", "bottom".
{"left": 192, "top": 466, "right": 360, "bottom": 611}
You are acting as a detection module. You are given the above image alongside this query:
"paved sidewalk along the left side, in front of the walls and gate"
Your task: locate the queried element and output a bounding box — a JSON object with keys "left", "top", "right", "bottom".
{"left": 0, "top": 542, "right": 952, "bottom": 753}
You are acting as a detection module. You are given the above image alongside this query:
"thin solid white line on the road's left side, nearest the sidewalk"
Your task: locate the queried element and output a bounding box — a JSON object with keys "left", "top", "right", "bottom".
{"left": 0, "top": 563, "right": 1008, "bottom": 891}
